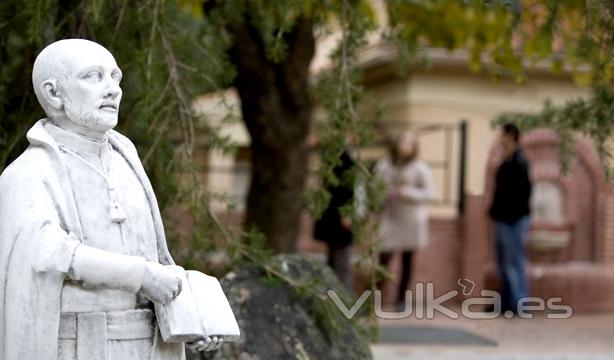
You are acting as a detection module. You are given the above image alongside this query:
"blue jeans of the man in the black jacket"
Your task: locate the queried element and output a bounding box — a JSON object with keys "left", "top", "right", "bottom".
{"left": 495, "top": 216, "right": 529, "bottom": 312}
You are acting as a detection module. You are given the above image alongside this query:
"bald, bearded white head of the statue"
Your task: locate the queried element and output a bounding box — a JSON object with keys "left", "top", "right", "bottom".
{"left": 32, "top": 39, "right": 122, "bottom": 136}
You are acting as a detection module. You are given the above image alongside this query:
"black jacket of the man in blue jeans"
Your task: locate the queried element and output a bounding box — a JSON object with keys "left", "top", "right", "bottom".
{"left": 490, "top": 150, "right": 531, "bottom": 224}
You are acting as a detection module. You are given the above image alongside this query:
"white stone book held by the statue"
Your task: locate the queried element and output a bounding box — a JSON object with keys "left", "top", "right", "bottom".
{"left": 155, "top": 270, "right": 240, "bottom": 342}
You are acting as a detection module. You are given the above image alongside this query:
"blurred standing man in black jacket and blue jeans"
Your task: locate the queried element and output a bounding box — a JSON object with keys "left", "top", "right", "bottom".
{"left": 490, "top": 123, "right": 531, "bottom": 313}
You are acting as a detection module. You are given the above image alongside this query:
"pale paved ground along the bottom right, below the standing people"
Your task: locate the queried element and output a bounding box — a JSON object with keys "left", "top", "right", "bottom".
{"left": 372, "top": 313, "right": 614, "bottom": 360}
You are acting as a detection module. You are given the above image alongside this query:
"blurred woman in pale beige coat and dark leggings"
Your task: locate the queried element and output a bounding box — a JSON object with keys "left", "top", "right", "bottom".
{"left": 375, "top": 131, "right": 435, "bottom": 306}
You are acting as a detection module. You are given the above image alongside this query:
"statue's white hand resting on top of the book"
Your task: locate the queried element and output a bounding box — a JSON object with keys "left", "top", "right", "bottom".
{"left": 141, "top": 261, "right": 181, "bottom": 304}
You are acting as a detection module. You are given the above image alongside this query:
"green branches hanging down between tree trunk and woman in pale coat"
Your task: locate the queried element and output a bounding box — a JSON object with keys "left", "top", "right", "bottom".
{"left": 305, "top": 0, "right": 383, "bottom": 332}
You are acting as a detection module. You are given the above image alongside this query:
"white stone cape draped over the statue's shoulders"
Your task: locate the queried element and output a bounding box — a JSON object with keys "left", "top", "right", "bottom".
{"left": 0, "top": 119, "right": 180, "bottom": 360}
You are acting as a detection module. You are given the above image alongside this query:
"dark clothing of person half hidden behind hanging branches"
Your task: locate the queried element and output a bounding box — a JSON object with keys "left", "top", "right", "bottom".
{"left": 313, "top": 151, "right": 354, "bottom": 248}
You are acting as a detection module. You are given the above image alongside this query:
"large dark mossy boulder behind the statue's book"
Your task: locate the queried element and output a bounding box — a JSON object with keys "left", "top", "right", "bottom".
{"left": 188, "top": 254, "right": 372, "bottom": 360}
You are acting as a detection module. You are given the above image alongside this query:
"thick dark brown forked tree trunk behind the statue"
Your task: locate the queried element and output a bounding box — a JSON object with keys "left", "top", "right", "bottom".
{"left": 229, "top": 18, "right": 314, "bottom": 252}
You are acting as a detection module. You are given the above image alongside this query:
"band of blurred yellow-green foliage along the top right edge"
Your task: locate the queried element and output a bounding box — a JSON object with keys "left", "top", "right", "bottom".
{"left": 388, "top": 0, "right": 614, "bottom": 85}
